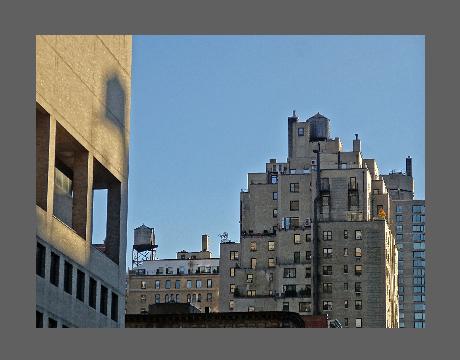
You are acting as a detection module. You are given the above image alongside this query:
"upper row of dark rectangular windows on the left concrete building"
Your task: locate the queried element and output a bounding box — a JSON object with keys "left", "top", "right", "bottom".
{"left": 36, "top": 242, "right": 118, "bottom": 321}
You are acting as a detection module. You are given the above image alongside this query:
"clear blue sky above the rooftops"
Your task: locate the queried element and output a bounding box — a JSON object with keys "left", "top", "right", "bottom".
{"left": 96, "top": 36, "right": 425, "bottom": 267}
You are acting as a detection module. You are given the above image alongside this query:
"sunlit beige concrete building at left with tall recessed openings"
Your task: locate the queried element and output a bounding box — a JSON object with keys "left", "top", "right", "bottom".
{"left": 36, "top": 35, "right": 131, "bottom": 327}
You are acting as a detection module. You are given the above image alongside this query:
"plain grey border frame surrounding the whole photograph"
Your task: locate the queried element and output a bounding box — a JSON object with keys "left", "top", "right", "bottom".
{"left": 0, "top": 0, "right": 460, "bottom": 359}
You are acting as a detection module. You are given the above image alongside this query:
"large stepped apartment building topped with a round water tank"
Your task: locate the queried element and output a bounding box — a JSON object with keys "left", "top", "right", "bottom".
{"left": 219, "top": 112, "right": 398, "bottom": 327}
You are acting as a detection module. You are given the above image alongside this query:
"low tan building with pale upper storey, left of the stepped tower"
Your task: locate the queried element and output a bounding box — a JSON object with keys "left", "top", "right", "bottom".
{"left": 126, "top": 235, "right": 220, "bottom": 314}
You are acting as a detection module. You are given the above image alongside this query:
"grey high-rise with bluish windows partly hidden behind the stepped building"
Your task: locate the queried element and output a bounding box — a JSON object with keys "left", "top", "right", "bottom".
{"left": 383, "top": 157, "right": 426, "bottom": 328}
